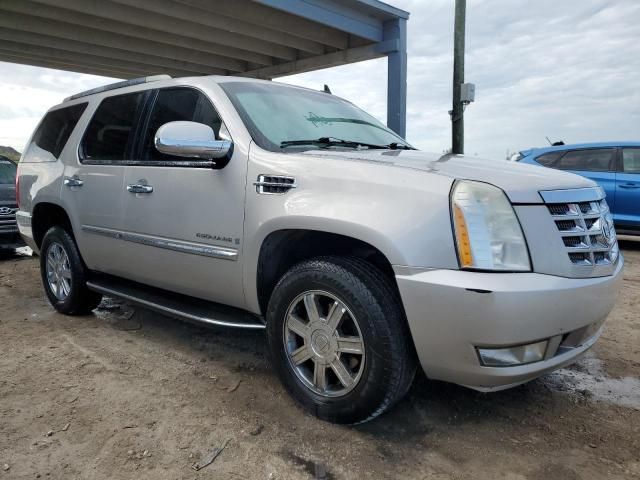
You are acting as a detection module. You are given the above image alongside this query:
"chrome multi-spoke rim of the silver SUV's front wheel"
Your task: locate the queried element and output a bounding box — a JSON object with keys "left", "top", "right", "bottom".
{"left": 284, "top": 290, "right": 365, "bottom": 397}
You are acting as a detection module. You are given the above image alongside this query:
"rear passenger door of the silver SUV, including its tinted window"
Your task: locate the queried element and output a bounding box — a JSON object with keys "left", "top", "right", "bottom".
{"left": 61, "top": 91, "right": 149, "bottom": 275}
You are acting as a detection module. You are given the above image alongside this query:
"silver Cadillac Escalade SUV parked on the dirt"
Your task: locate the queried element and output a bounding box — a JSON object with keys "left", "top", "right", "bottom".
{"left": 17, "top": 76, "right": 623, "bottom": 423}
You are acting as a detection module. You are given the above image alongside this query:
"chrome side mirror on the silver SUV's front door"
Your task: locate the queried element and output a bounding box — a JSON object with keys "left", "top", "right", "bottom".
{"left": 154, "top": 121, "right": 233, "bottom": 160}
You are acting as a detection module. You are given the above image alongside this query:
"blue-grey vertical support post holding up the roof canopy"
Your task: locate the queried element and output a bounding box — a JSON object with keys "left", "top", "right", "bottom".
{"left": 384, "top": 18, "right": 407, "bottom": 138}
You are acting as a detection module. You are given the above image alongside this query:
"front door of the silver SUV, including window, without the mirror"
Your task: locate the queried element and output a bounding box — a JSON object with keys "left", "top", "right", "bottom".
{"left": 117, "top": 87, "right": 247, "bottom": 307}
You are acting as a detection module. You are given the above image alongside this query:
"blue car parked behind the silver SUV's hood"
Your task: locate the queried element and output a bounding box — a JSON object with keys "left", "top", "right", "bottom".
{"left": 517, "top": 142, "right": 640, "bottom": 235}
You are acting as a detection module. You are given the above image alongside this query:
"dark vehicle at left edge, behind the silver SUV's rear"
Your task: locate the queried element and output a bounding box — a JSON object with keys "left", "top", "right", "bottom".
{"left": 0, "top": 155, "right": 24, "bottom": 250}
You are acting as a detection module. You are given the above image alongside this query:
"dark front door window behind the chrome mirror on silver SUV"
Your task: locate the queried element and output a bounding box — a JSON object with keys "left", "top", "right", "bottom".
{"left": 141, "top": 88, "right": 222, "bottom": 161}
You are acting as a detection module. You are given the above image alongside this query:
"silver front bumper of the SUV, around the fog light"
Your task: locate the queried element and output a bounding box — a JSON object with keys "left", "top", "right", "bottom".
{"left": 396, "top": 256, "right": 623, "bottom": 391}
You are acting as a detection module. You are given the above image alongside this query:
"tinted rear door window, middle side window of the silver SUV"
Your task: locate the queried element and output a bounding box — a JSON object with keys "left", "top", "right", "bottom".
{"left": 82, "top": 92, "right": 147, "bottom": 160}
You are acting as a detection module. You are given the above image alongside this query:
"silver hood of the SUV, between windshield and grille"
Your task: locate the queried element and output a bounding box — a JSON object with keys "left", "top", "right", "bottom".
{"left": 303, "top": 150, "right": 596, "bottom": 203}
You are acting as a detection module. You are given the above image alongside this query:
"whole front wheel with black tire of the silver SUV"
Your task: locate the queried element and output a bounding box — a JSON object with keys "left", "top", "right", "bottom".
{"left": 267, "top": 257, "right": 417, "bottom": 424}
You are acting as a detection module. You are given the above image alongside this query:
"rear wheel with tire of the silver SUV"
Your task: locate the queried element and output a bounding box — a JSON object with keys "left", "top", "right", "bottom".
{"left": 40, "top": 226, "right": 102, "bottom": 315}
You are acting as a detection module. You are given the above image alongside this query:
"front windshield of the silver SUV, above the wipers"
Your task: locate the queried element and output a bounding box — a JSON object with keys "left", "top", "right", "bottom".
{"left": 220, "top": 82, "right": 408, "bottom": 152}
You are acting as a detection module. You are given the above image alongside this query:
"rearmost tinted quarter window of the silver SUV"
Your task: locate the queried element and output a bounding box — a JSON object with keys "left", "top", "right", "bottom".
{"left": 33, "top": 103, "right": 87, "bottom": 158}
